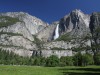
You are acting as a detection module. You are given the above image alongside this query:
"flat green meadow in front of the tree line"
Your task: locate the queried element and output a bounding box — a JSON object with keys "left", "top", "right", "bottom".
{"left": 0, "top": 66, "right": 100, "bottom": 75}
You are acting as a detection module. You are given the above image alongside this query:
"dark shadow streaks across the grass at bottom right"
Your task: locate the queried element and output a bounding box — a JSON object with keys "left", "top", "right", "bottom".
{"left": 59, "top": 68, "right": 100, "bottom": 75}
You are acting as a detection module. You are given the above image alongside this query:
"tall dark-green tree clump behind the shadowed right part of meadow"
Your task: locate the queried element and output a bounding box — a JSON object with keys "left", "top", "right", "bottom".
{"left": 73, "top": 52, "right": 94, "bottom": 66}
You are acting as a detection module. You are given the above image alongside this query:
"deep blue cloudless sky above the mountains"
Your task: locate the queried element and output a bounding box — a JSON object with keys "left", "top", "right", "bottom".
{"left": 0, "top": 0, "right": 100, "bottom": 23}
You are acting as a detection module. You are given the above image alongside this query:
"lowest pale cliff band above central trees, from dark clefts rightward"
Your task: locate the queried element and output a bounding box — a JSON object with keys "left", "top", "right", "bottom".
{"left": 33, "top": 50, "right": 72, "bottom": 58}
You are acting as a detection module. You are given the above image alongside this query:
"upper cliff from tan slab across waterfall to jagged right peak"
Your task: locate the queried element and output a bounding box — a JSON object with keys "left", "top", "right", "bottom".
{"left": 37, "top": 9, "right": 90, "bottom": 41}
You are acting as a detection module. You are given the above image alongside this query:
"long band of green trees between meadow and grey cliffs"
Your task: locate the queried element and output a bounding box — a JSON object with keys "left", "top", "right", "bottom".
{"left": 0, "top": 49, "right": 100, "bottom": 67}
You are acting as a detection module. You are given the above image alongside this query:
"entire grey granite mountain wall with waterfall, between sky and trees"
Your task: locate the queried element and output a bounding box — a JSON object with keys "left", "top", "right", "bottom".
{"left": 0, "top": 10, "right": 100, "bottom": 58}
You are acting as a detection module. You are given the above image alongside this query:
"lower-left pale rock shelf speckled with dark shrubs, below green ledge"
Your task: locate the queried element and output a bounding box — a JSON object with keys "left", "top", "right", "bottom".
{"left": 0, "top": 33, "right": 36, "bottom": 50}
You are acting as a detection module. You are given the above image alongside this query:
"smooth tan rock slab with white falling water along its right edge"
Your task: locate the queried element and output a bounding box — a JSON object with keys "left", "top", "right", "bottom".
{"left": 36, "top": 21, "right": 59, "bottom": 42}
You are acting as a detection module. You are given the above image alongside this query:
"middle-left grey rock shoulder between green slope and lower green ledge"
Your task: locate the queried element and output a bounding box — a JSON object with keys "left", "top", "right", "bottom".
{"left": 0, "top": 22, "right": 34, "bottom": 41}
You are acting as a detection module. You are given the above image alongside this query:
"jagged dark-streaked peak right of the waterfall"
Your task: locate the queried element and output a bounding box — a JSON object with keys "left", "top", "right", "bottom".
{"left": 59, "top": 9, "right": 90, "bottom": 37}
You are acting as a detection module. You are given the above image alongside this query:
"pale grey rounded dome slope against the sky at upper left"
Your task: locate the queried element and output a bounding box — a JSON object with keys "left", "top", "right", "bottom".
{"left": 0, "top": 12, "right": 48, "bottom": 35}
